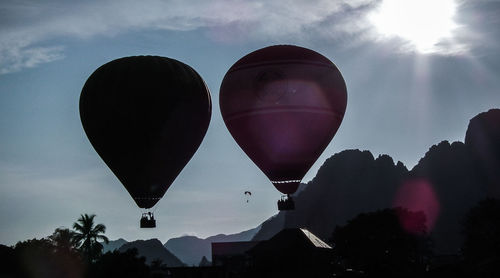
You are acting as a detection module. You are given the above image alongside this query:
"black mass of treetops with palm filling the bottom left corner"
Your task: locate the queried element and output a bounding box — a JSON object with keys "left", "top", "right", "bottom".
{"left": 0, "top": 214, "right": 174, "bottom": 278}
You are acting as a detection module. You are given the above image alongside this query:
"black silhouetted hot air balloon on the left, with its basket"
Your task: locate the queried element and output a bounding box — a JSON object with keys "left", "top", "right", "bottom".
{"left": 80, "top": 56, "right": 212, "bottom": 226}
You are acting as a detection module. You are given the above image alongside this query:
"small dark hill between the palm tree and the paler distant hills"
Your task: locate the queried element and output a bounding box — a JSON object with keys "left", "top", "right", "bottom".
{"left": 118, "top": 239, "right": 184, "bottom": 267}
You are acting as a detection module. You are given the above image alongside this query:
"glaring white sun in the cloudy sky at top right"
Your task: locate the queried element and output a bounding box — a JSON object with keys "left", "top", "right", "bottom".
{"left": 370, "top": 0, "right": 456, "bottom": 53}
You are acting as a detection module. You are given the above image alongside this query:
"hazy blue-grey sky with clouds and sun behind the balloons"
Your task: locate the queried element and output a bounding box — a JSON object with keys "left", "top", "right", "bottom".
{"left": 0, "top": 0, "right": 500, "bottom": 245}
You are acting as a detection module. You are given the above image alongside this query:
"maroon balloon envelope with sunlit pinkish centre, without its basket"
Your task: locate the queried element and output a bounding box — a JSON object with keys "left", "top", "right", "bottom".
{"left": 219, "top": 45, "right": 347, "bottom": 211}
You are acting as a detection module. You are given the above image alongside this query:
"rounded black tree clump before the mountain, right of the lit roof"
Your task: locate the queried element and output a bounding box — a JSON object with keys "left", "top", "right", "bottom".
{"left": 331, "top": 208, "right": 432, "bottom": 277}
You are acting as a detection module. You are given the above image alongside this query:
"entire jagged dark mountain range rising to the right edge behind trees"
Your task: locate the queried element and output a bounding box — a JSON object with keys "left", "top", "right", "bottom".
{"left": 253, "top": 109, "right": 500, "bottom": 253}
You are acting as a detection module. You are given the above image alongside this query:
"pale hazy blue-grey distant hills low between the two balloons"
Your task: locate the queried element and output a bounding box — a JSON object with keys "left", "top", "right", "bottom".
{"left": 165, "top": 226, "right": 260, "bottom": 266}
